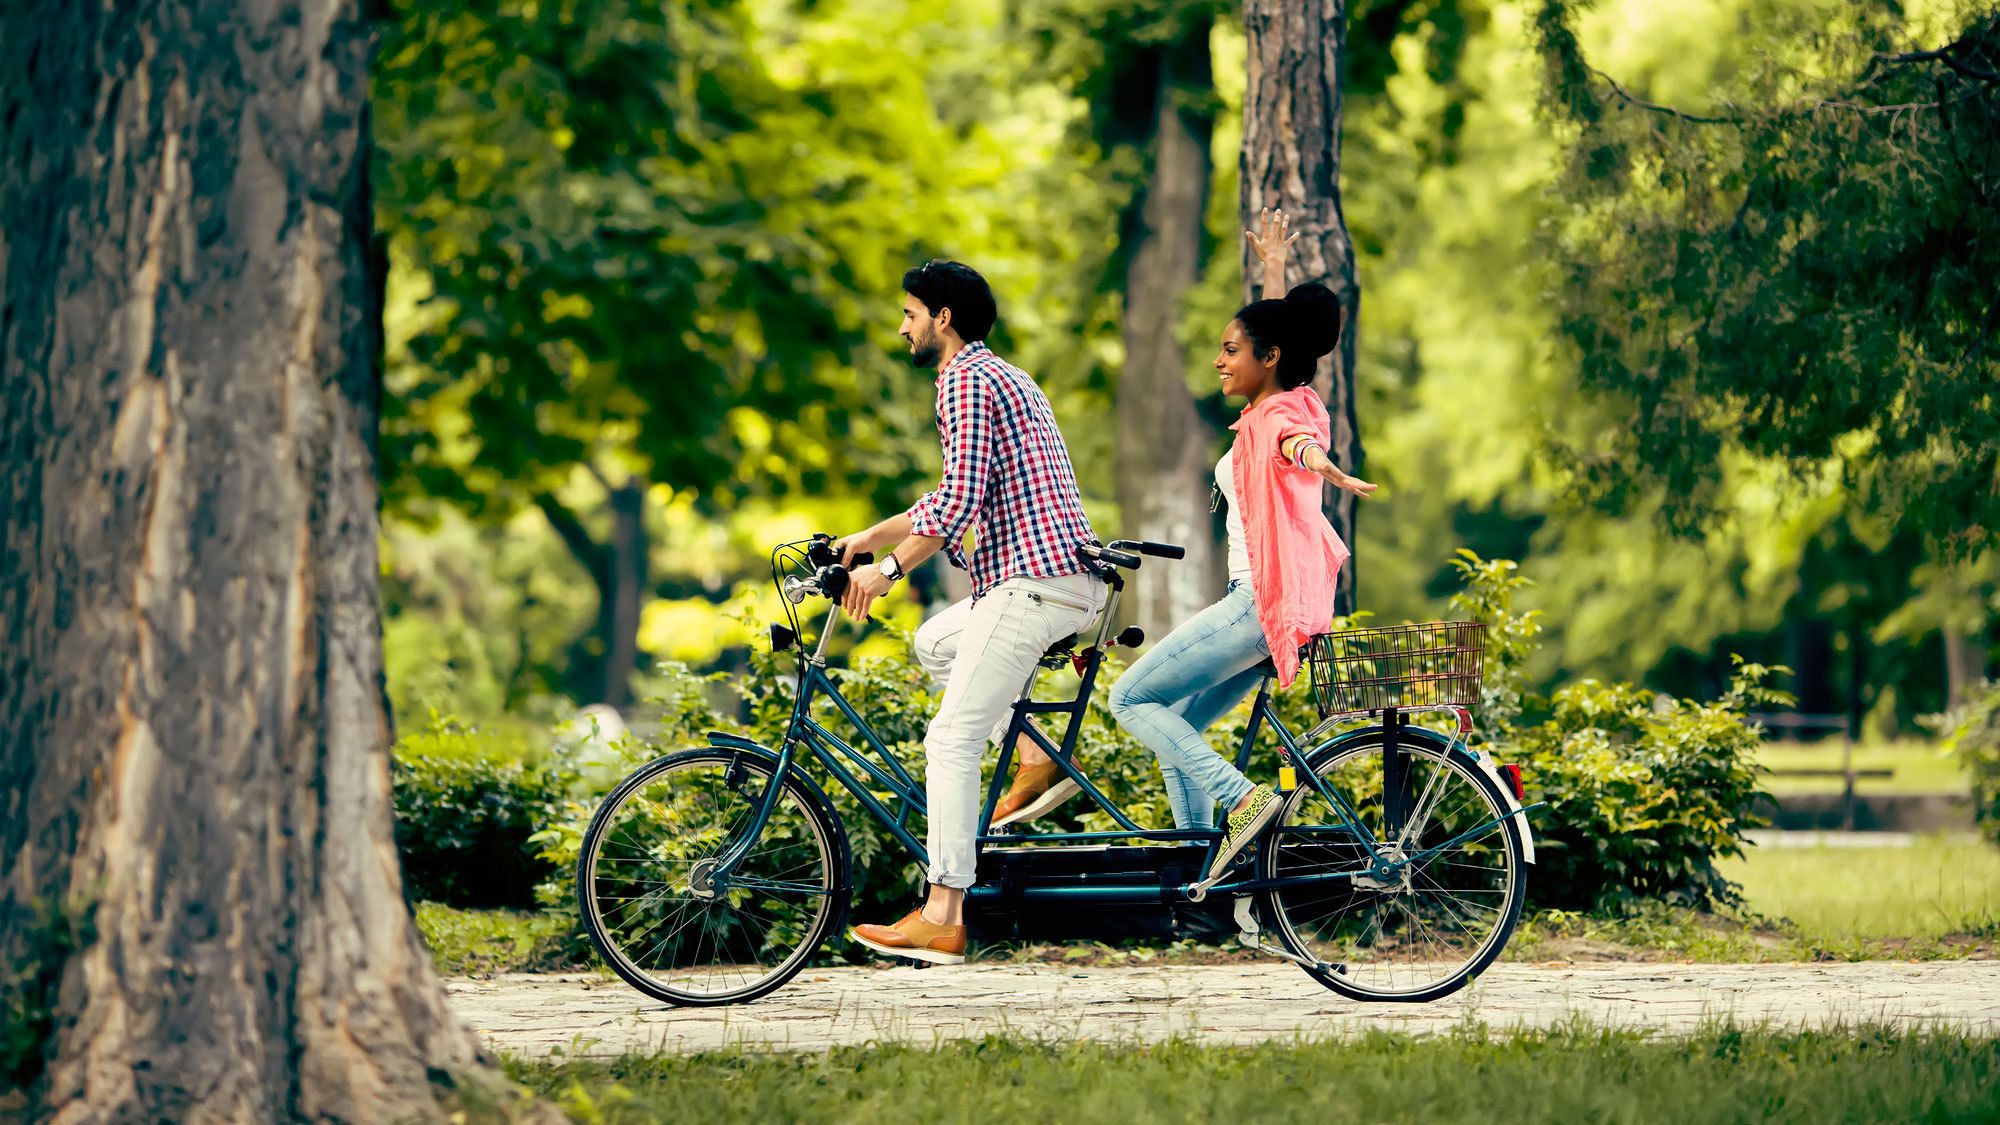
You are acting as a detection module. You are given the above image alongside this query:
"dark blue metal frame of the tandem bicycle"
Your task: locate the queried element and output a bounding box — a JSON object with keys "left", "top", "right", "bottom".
{"left": 712, "top": 540, "right": 1532, "bottom": 903}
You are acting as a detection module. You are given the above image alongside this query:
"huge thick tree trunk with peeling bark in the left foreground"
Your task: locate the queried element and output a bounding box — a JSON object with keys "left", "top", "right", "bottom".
{"left": 0, "top": 0, "right": 478, "bottom": 1121}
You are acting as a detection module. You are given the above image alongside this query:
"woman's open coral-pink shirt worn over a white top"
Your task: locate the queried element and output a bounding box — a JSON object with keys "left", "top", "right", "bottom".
{"left": 1230, "top": 386, "right": 1348, "bottom": 687}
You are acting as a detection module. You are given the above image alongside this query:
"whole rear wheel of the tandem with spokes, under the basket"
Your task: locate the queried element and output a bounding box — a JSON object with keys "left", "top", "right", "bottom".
{"left": 1260, "top": 733, "right": 1526, "bottom": 1001}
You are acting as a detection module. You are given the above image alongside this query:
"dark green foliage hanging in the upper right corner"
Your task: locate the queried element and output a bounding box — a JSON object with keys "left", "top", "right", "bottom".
{"left": 1536, "top": 0, "right": 2000, "bottom": 554}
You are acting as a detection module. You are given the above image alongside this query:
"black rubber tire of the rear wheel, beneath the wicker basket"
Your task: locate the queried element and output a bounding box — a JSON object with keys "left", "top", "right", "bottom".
{"left": 1258, "top": 731, "right": 1528, "bottom": 1003}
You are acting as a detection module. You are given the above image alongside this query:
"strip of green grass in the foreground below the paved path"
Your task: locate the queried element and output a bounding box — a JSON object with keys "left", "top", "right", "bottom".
{"left": 468, "top": 1027, "right": 2000, "bottom": 1125}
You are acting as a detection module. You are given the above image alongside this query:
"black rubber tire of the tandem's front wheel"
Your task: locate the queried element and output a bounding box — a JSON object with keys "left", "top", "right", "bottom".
{"left": 576, "top": 747, "right": 852, "bottom": 1007}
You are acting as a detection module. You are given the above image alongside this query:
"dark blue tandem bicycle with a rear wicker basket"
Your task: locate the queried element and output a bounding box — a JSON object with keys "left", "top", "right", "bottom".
{"left": 576, "top": 534, "right": 1538, "bottom": 1005}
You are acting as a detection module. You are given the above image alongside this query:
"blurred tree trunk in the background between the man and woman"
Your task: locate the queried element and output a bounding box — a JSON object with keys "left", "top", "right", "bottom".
{"left": 1116, "top": 28, "right": 1224, "bottom": 637}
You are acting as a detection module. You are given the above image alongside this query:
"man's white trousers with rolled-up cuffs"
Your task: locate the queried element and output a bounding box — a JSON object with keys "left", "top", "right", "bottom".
{"left": 916, "top": 575, "right": 1104, "bottom": 889}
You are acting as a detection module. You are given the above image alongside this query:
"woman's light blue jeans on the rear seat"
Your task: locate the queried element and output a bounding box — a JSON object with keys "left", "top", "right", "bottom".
{"left": 1112, "top": 583, "right": 1270, "bottom": 829}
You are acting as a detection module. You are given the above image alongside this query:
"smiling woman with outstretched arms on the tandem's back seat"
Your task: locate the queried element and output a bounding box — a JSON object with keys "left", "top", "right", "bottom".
{"left": 1112, "top": 210, "right": 1376, "bottom": 877}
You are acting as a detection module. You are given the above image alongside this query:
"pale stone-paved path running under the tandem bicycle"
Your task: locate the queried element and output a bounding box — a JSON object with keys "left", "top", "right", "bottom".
{"left": 448, "top": 961, "right": 2000, "bottom": 1055}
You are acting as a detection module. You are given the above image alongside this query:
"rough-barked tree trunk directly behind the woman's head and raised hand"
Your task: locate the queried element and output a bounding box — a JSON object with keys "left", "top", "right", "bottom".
{"left": 1238, "top": 0, "right": 1364, "bottom": 613}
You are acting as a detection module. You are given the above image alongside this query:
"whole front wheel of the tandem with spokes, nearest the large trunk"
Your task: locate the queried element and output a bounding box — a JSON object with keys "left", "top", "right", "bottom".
{"left": 576, "top": 749, "right": 848, "bottom": 1005}
